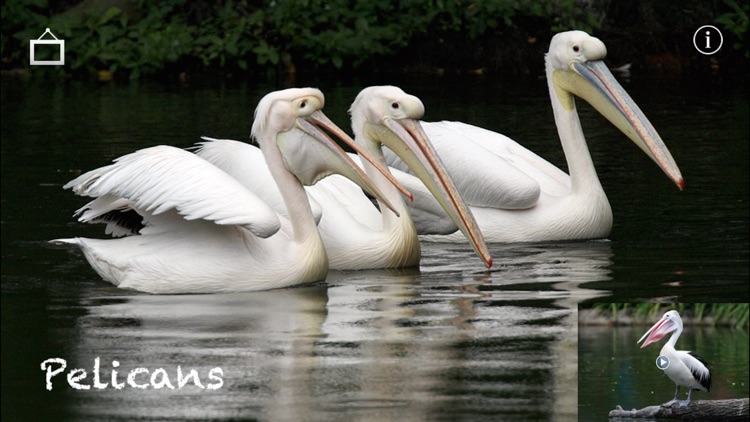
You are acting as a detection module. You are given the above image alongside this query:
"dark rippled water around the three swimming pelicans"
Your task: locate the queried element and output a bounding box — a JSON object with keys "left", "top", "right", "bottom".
{"left": 1, "top": 71, "right": 750, "bottom": 421}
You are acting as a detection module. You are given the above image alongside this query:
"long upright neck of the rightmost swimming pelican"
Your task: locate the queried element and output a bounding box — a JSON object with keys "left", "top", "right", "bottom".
{"left": 546, "top": 58, "right": 602, "bottom": 193}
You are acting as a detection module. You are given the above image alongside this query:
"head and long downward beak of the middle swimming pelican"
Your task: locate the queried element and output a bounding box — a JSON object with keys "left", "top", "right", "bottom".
{"left": 349, "top": 86, "right": 492, "bottom": 267}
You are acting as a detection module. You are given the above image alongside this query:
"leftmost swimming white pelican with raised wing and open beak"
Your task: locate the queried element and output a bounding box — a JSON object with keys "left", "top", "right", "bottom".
{"left": 52, "top": 88, "right": 408, "bottom": 293}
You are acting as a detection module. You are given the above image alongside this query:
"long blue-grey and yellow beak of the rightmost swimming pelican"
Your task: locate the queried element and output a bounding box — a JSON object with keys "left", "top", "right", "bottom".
{"left": 553, "top": 60, "right": 685, "bottom": 189}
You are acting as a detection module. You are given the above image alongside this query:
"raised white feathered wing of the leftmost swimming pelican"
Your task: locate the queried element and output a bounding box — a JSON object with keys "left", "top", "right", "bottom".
{"left": 64, "top": 145, "right": 280, "bottom": 238}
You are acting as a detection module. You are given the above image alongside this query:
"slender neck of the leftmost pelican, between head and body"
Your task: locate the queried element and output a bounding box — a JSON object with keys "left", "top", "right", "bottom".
{"left": 261, "top": 140, "right": 322, "bottom": 242}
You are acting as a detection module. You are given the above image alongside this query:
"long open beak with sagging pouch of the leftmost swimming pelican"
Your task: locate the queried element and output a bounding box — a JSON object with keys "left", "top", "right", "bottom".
{"left": 277, "top": 110, "right": 411, "bottom": 215}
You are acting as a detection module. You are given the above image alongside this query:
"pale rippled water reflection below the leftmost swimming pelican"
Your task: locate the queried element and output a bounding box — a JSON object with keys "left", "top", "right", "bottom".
{"left": 67, "top": 285, "right": 327, "bottom": 419}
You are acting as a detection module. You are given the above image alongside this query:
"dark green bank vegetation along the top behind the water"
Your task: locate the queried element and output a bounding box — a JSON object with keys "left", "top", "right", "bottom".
{"left": 2, "top": 0, "right": 748, "bottom": 79}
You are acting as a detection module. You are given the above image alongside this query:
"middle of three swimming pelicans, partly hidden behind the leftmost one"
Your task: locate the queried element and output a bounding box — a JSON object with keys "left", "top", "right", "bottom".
{"left": 198, "top": 86, "right": 492, "bottom": 270}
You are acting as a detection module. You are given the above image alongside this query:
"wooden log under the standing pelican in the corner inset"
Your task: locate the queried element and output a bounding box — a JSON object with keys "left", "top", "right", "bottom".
{"left": 609, "top": 398, "right": 750, "bottom": 421}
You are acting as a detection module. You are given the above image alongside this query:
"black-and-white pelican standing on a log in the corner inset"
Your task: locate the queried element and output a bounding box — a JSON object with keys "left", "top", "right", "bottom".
{"left": 638, "top": 311, "right": 711, "bottom": 407}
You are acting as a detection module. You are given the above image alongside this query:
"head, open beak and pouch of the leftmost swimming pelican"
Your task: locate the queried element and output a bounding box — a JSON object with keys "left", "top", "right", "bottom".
{"left": 252, "top": 88, "right": 408, "bottom": 216}
